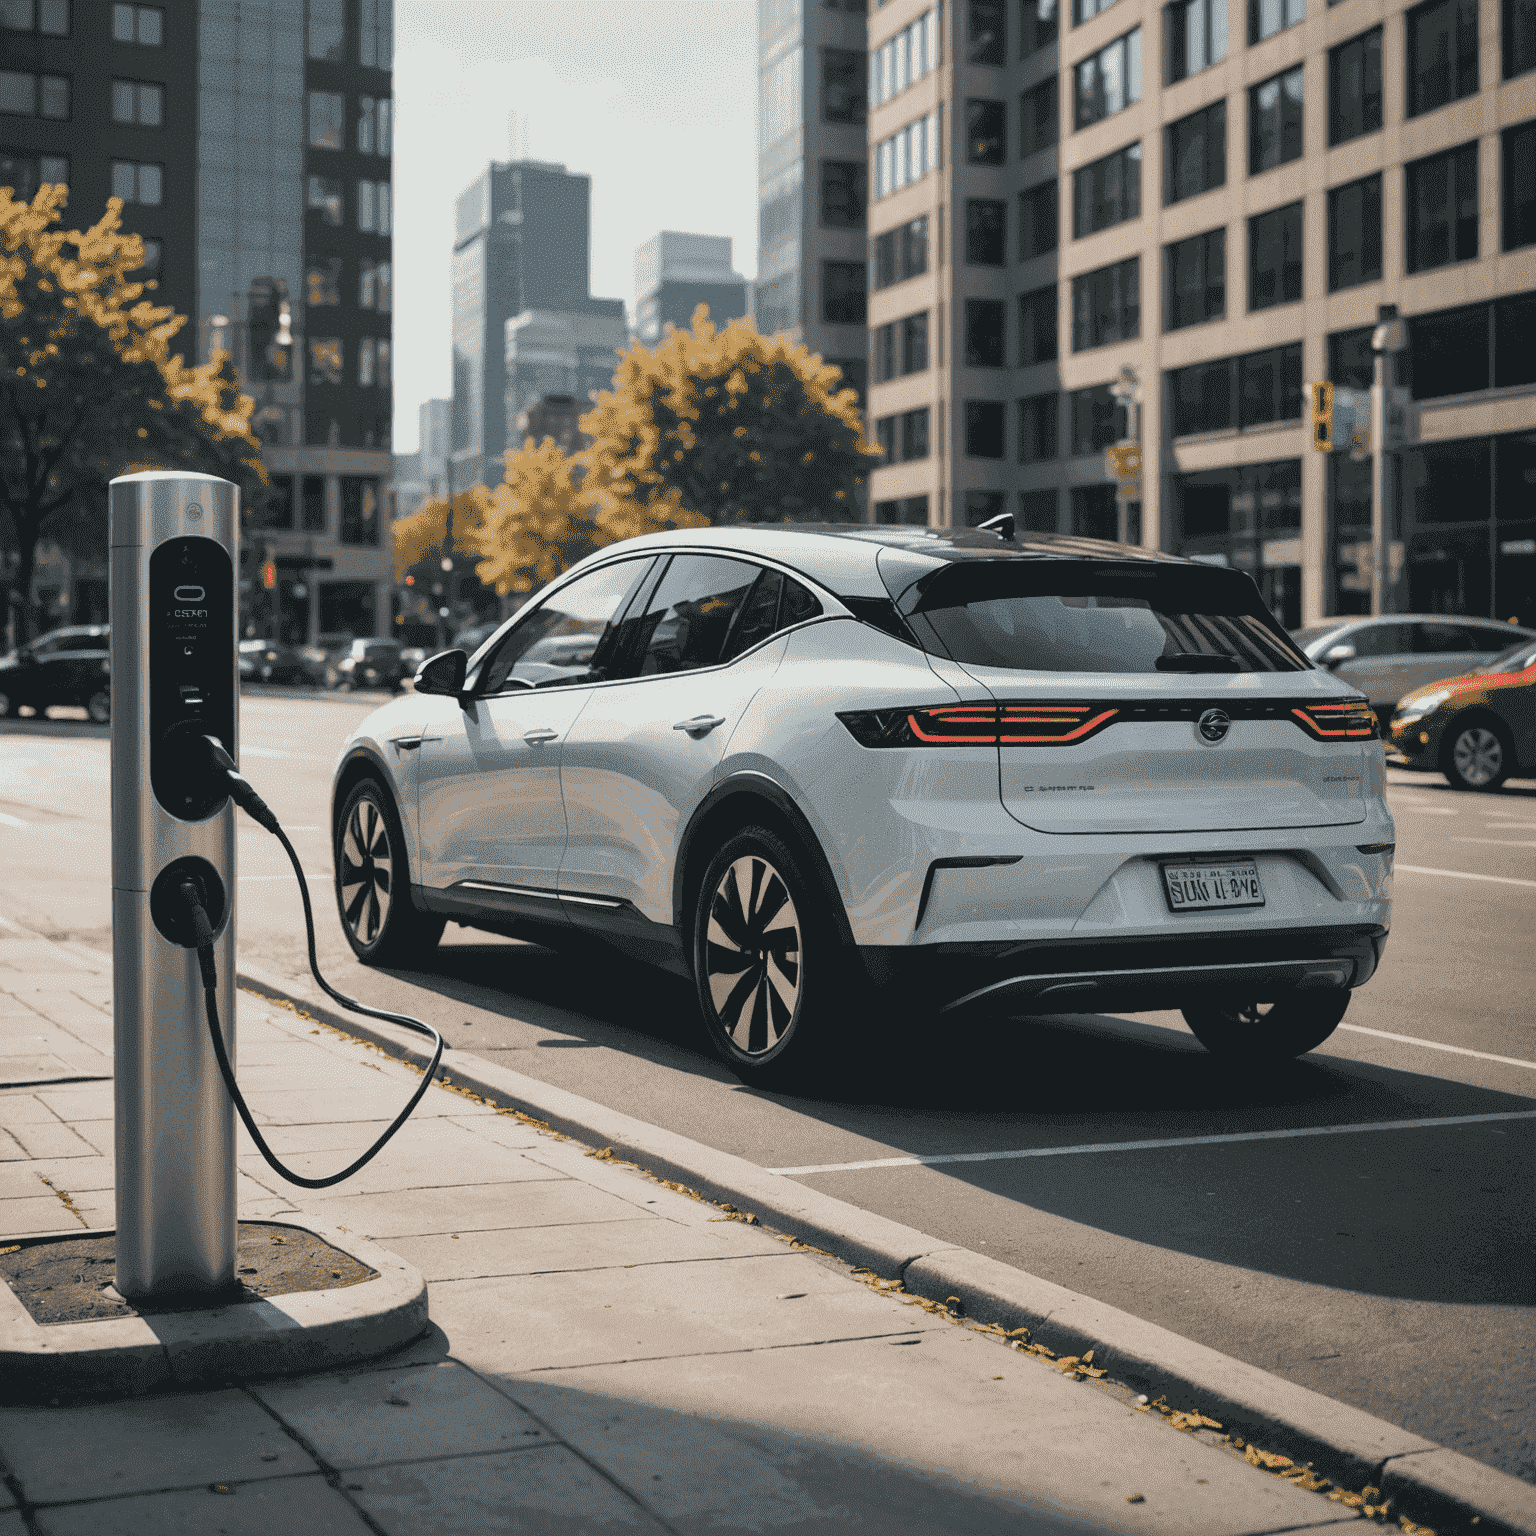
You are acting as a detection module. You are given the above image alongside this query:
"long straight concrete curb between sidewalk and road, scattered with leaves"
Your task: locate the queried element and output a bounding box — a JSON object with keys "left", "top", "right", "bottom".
{"left": 237, "top": 966, "right": 1536, "bottom": 1536}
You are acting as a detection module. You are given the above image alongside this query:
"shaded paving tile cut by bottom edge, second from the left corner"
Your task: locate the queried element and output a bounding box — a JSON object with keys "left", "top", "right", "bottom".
{"left": 352, "top": 1445, "right": 665, "bottom": 1536}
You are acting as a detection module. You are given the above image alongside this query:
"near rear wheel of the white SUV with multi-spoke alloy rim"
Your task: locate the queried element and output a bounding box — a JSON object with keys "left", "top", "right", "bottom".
{"left": 693, "top": 826, "right": 857, "bottom": 1087}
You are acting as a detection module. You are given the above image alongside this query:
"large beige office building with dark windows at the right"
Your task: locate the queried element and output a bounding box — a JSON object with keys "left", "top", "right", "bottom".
{"left": 869, "top": 0, "right": 1536, "bottom": 625}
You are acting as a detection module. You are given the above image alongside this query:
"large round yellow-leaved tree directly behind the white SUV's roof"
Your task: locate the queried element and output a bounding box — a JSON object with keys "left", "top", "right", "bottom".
{"left": 579, "top": 304, "right": 880, "bottom": 542}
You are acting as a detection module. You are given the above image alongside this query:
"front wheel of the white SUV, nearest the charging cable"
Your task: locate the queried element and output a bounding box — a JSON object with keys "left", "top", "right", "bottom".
{"left": 333, "top": 779, "right": 447, "bottom": 966}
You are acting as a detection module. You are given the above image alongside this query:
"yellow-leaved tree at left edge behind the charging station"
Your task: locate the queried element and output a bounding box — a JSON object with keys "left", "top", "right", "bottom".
{"left": 0, "top": 186, "right": 266, "bottom": 642}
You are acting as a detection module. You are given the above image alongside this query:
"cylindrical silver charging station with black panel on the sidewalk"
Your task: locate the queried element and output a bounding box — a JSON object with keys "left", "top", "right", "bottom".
{"left": 109, "top": 472, "right": 240, "bottom": 1298}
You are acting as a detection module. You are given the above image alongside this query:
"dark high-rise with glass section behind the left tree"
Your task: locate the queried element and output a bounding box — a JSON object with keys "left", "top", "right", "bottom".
{"left": 0, "top": 0, "right": 393, "bottom": 641}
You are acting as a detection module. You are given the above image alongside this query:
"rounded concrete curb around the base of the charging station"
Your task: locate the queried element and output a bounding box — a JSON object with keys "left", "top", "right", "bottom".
{"left": 0, "top": 1221, "right": 430, "bottom": 1404}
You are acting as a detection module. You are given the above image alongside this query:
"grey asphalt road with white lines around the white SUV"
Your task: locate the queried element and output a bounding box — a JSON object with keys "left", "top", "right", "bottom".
{"left": 0, "top": 696, "right": 1536, "bottom": 1482}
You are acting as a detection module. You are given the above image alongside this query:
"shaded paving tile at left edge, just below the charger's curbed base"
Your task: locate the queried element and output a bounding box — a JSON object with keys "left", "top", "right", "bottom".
{"left": 0, "top": 1389, "right": 316, "bottom": 1504}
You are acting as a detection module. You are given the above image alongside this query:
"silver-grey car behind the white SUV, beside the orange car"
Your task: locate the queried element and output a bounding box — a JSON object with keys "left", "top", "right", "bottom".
{"left": 1290, "top": 613, "right": 1536, "bottom": 722}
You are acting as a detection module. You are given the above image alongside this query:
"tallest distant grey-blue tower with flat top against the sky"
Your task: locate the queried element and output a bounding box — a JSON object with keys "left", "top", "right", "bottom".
{"left": 452, "top": 160, "right": 624, "bottom": 490}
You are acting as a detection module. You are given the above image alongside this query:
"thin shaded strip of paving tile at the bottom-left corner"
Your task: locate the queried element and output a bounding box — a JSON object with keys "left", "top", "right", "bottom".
{"left": 29, "top": 1473, "right": 369, "bottom": 1536}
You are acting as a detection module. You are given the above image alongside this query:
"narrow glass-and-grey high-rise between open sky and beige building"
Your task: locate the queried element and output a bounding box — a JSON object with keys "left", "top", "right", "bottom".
{"left": 753, "top": 0, "right": 872, "bottom": 399}
